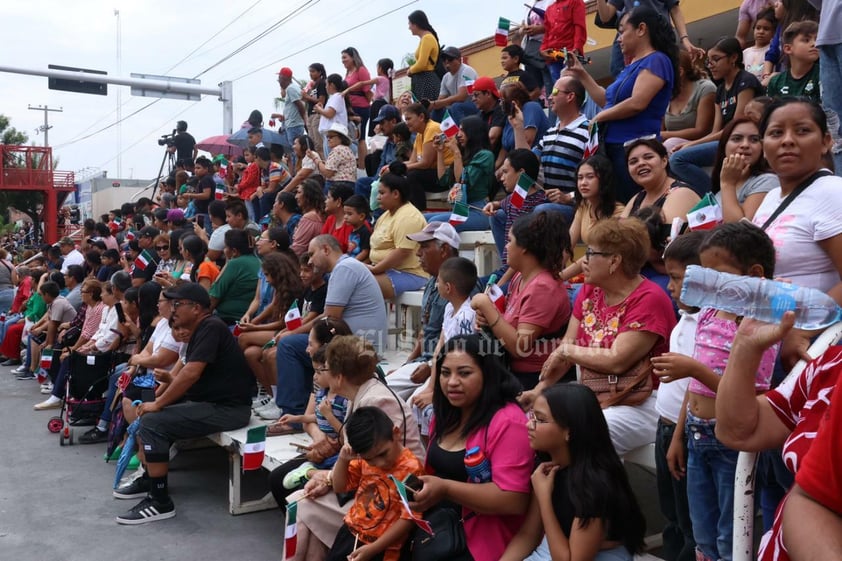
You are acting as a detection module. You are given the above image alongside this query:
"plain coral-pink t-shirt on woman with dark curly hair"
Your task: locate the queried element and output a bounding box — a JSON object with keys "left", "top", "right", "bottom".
{"left": 503, "top": 271, "right": 570, "bottom": 374}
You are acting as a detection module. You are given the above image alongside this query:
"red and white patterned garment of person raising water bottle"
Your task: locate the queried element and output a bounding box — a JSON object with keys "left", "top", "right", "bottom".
{"left": 757, "top": 346, "right": 842, "bottom": 561}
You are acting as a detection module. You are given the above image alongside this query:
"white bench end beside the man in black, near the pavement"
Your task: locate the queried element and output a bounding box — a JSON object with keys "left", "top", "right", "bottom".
{"left": 207, "top": 416, "right": 312, "bottom": 515}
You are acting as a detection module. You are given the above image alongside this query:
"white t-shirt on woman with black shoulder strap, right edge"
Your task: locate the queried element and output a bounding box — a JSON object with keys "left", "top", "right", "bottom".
{"left": 753, "top": 175, "right": 842, "bottom": 292}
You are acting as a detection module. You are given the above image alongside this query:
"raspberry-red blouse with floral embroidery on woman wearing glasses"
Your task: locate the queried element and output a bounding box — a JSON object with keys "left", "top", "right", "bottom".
{"left": 573, "top": 279, "right": 676, "bottom": 356}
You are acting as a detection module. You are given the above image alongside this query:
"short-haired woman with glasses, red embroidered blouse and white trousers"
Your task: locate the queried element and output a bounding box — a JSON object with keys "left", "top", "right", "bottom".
{"left": 521, "top": 219, "right": 675, "bottom": 455}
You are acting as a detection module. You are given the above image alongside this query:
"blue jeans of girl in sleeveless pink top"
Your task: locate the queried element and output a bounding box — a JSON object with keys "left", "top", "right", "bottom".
{"left": 685, "top": 411, "right": 739, "bottom": 561}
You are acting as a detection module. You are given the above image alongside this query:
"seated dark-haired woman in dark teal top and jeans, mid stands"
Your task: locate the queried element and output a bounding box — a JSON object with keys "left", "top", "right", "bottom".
{"left": 425, "top": 115, "right": 494, "bottom": 232}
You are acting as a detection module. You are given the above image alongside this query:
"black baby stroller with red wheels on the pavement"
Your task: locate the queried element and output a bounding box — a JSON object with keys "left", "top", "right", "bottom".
{"left": 47, "top": 352, "right": 118, "bottom": 446}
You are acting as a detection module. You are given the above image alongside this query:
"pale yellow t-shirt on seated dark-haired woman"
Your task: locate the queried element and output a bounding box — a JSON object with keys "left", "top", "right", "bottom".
{"left": 369, "top": 203, "right": 429, "bottom": 278}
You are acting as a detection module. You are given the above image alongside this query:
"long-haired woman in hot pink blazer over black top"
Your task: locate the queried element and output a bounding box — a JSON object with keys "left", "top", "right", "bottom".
{"left": 406, "top": 334, "right": 533, "bottom": 560}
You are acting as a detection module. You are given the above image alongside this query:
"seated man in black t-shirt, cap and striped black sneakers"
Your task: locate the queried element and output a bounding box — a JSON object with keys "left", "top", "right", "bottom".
{"left": 113, "top": 283, "right": 255, "bottom": 524}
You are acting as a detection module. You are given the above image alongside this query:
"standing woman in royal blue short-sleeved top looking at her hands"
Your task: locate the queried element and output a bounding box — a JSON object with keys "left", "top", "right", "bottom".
{"left": 568, "top": 7, "right": 678, "bottom": 204}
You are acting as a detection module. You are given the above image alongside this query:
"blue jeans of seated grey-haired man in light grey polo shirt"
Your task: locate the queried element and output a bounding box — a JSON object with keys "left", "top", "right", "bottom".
{"left": 275, "top": 334, "right": 313, "bottom": 415}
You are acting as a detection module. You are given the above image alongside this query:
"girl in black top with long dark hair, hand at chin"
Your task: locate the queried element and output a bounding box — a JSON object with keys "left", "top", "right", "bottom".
{"left": 500, "top": 384, "right": 646, "bottom": 561}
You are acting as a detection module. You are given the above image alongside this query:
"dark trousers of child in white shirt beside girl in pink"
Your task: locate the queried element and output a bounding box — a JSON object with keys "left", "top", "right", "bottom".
{"left": 655, "top": 420, "right": 696, "bottom": 561}
